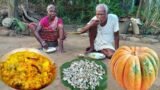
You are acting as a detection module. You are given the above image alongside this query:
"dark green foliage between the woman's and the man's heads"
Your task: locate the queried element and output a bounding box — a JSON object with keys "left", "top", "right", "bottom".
{"left": 56, "top": 0, "right": 96, "bottom": 23}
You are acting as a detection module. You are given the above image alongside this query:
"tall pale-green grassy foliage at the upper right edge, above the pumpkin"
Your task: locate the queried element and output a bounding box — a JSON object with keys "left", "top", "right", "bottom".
{"left": 140, "top": 0, "right": 160, "bottom": 34}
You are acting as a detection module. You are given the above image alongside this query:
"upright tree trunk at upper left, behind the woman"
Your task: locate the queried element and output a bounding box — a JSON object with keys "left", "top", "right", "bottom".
{"left": 8, "top": 0, "right": 18, "bottom": 18}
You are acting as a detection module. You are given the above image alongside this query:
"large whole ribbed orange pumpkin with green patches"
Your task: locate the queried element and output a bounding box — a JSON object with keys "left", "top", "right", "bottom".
{"left": 110, "top": 46, "right": 159, "bottom": 90}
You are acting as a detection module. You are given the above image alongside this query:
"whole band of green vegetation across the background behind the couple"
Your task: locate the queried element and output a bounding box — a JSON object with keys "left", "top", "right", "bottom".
{"left": 0, "top": 0, "right": 160, "bottom": 34}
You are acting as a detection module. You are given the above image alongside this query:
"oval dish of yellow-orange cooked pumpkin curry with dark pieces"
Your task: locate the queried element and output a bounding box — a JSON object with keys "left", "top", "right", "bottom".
{"left": 0, "top": 48, "right": 56, "bottom": 90}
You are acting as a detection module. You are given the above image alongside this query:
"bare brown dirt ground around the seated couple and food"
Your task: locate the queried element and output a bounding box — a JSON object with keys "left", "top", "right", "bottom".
{"left": 0, "top": 28, "right": 160, "bottom": 90}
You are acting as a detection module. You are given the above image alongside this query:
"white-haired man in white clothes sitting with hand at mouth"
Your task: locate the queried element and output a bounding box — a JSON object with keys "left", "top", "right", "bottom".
{"left": 79, "top": 4, "right": 119, "bottom": 58}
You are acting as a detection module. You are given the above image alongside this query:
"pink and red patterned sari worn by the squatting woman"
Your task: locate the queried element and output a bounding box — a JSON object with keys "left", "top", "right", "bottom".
{"left": 28, "top": 16, "right": 65, "bottom": 46}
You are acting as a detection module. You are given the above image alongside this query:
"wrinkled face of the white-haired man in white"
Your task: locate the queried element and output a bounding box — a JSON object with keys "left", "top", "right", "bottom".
{"left": 96, "top": 7, "right": 107, "bottom": 23}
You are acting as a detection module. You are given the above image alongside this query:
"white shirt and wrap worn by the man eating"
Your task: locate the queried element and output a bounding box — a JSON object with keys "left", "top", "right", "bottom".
{"left": 91, "top": 14, "right": 119, "bottom": 51}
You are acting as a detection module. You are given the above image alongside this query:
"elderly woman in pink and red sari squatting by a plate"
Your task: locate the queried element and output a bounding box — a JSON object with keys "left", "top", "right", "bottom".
{"left": 29, "top": 4, "right": 65, "bottom": 52}
